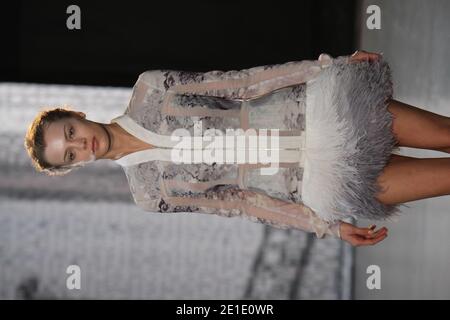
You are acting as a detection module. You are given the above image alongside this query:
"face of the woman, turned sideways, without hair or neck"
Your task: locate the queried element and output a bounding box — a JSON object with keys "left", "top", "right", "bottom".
{"left": 44, "top": 115, "right": 111, "bottom": 166}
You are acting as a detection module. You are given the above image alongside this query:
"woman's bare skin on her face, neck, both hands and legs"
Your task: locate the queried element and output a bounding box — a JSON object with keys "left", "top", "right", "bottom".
{"left": 44, "top": 51, "right": 450, "bottom": 246}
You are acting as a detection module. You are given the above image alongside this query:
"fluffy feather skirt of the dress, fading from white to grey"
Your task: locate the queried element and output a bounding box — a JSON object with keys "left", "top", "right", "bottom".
{"left": 302, "top": 57, "right": 406, "bottom": 221}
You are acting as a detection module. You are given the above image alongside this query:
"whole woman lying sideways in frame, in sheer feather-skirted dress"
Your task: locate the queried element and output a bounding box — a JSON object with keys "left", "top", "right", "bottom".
{"left": 25, "top": 51, "right": 450, "bottom": 246}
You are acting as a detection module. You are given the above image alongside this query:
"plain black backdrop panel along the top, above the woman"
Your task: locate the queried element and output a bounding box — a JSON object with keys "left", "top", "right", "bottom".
{"left": 0, "top": 1, "right": 356, "bottom": 86}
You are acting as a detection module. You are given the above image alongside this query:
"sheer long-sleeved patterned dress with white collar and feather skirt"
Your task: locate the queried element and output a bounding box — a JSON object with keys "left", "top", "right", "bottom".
{"left": 111, "top": 54, "right": 406, "bottom": 238}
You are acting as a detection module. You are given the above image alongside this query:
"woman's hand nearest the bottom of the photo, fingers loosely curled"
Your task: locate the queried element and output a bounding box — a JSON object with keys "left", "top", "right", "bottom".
{"left": 339, "top": 221, "right": 388, "bottom": 247}
